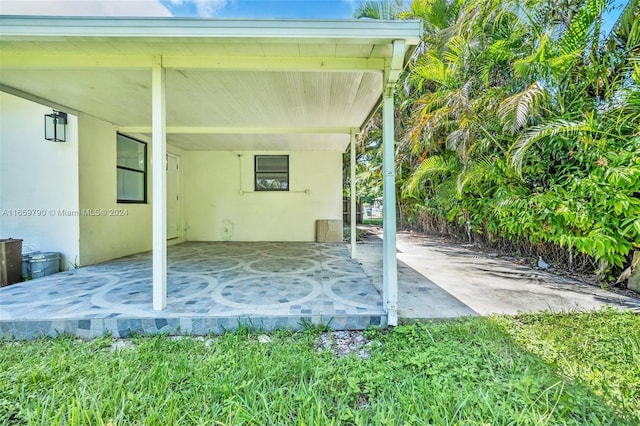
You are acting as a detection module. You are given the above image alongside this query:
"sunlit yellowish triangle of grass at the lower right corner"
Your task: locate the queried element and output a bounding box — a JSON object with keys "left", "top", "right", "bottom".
{"left": 502, "top": 309, "right": 640, "bottom": 424}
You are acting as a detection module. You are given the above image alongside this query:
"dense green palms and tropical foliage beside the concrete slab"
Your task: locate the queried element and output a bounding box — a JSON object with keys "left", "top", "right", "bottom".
{"left": 357, "top": 0, "right": 640, "bottom": 276}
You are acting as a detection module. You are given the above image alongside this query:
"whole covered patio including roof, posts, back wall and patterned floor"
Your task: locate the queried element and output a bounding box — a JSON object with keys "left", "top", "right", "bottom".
{"left": 0, "top": 16, "right": 422, "bottom": 335}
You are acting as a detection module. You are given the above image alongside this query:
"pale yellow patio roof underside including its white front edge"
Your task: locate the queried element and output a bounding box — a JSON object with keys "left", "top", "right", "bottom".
{"left": 0, "top": 16, "right": 421, "bottom": 150}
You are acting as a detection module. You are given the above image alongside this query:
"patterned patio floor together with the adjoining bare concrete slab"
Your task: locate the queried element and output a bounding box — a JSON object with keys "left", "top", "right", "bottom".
{"left": 0, "top": 229, "right": 640, "bottom": 338}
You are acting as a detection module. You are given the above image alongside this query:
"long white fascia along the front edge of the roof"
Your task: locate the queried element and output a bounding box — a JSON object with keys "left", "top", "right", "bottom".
{"left": 0, "top": 15, "right": 422, "bottom": 45}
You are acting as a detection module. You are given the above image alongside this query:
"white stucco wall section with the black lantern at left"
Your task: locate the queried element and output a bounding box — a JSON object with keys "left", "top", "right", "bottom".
{"left": 0, "top": 92, "right": 80, "bottom": 270}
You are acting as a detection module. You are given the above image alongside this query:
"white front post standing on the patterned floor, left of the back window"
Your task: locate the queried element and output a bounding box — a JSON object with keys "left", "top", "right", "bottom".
{"left": 151, "top": 55, "right": 167, "bottom": 311}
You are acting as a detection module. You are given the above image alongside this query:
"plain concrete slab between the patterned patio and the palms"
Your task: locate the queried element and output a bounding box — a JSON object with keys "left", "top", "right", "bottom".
{"left": 358, "top": 230, "right": 640, "bottom": 320}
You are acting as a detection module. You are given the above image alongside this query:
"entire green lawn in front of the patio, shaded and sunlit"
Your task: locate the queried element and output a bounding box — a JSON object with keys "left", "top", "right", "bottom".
{"left": 0, "top": 310, "right": 640, "bottom": 426}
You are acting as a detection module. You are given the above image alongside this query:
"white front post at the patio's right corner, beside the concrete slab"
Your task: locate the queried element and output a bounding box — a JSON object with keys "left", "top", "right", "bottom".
{"left": 382, "top": 89, "right": 398, "bottom": 326}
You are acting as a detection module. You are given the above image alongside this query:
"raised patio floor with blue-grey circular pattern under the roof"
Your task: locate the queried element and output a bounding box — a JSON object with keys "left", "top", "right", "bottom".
{"left": 0, "top": 242, "right": 387, "bottom": 338}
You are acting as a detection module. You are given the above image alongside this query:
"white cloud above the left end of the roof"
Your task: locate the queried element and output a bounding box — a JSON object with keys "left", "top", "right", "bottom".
{"left": 0, "top": 0, "right": 171, "bottom": 16}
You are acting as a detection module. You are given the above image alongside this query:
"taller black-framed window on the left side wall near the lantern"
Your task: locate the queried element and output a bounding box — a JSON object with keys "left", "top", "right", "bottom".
{"left": 116, "top": 133, "right": 147, "bottom": 203}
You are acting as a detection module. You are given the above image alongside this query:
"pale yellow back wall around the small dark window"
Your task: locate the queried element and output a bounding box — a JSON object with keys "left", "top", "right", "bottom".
{"left": 183, "top": 151, "right": 342, "bottom": 241}
